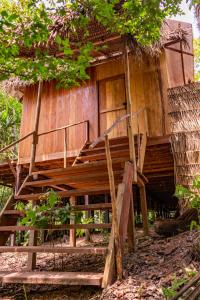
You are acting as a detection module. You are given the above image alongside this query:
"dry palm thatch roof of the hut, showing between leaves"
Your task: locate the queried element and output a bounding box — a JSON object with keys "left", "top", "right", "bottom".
{"left": 1, "top": 16, "right": 191, "bottom": 99}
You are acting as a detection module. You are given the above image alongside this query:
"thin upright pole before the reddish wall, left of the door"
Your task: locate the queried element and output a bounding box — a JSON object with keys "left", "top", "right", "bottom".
{"left": 29, "top": 81, "right": 42, "bottom": 175}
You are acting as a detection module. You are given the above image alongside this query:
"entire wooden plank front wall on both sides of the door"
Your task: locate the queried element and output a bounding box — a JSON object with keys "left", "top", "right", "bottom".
{"left": 19, "top": 51, "right": 172, "bottom": 163}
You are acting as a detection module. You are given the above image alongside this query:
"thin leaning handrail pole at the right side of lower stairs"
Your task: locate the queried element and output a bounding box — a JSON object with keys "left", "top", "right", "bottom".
{"left": 105, "top": 135, "right": 123, "bottom": 279}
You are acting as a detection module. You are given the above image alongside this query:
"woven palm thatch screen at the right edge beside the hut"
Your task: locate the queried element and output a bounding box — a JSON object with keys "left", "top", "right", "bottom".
{"left": 168, "top": 82, "right": 200, "bottom": 188}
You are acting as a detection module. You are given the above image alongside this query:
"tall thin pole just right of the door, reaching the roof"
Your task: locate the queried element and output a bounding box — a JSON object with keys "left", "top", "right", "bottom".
{"left": 124, "top": 45, "right": 137, "bottom": 182}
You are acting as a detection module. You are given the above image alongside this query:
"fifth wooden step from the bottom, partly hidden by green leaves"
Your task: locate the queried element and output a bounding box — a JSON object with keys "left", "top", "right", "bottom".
{"left": 15, "top": 186, "right": 110, "bottom": 201}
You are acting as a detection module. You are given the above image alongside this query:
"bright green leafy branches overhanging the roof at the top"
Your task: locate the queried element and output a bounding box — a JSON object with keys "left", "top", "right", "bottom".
{"left": 0, "top": 0, "right": 185, "bottom": 87}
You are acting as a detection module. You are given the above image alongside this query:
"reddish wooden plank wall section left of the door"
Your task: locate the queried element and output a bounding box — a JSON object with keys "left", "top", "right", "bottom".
{"left": 19, "top": 70, "right": 98, "bottom": 163}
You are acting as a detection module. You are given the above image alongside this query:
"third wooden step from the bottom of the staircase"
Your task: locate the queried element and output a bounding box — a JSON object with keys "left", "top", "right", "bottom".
{"left": 0, "top": 223, "right": 112, "bottom": 232}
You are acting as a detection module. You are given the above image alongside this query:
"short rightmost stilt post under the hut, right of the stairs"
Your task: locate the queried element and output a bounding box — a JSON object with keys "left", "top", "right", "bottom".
{"left": 138, "top": 178, "right": 149, "bottom": 235}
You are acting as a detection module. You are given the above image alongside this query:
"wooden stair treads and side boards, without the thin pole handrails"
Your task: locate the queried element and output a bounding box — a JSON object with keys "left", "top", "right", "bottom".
{"left": 0, "top": 137, "right": 139, "bottom": 287}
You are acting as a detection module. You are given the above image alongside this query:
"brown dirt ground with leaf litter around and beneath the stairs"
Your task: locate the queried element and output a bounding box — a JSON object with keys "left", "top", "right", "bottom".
{"left": 0, "top": 231, "right": 200, "bottom": 300}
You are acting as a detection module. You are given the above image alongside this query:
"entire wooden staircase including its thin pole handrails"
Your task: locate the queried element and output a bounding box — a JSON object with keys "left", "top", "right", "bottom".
{"left": 0, "top": 106, "right": 148, "bottom": 287}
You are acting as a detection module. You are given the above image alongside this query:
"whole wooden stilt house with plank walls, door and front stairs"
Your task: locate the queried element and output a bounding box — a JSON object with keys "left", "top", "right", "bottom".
{"left": 0, "top": 21, "right": 194, "bottom": 287}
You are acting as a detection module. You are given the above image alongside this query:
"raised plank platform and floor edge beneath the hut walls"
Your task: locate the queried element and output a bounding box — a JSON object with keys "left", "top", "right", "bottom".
{"left": 0, "top": 136, "right": 175, "bottom": 201}
